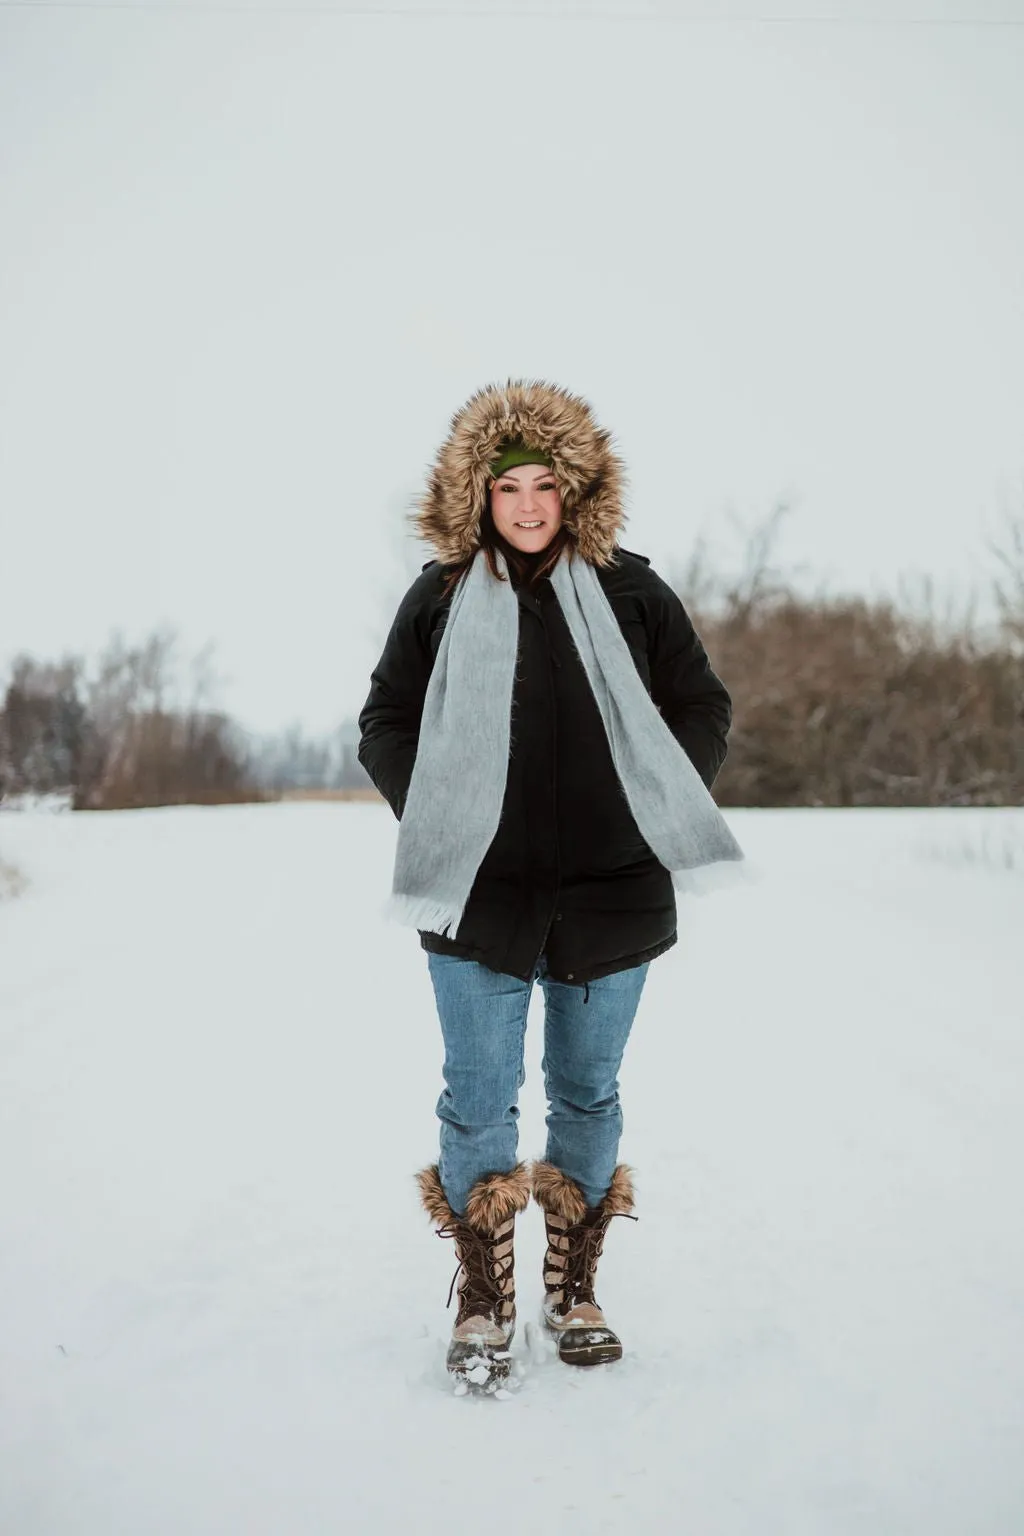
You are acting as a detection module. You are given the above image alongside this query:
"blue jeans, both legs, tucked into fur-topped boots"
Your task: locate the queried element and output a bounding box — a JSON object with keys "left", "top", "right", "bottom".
{"left": 427, "top": 951, "right": 651, "bottom": 1215}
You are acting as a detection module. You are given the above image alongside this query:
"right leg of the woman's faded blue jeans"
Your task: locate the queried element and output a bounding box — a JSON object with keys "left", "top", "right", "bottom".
{"left": 540, "top": 960, "right": 651, "bottom": 1206}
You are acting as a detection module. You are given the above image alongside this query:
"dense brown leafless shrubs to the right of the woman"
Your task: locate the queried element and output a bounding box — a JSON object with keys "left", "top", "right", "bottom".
{"left": 680, "top": 511, "right": 1024, "bottom": 805}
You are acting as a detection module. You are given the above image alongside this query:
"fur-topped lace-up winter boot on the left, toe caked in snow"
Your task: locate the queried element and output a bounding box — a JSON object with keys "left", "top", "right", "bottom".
{"left": 416, "top": 1163, "right": 530, "bottom": 1392}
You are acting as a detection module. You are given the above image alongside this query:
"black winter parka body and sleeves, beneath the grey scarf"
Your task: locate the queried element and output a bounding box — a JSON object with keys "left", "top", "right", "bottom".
{"left": 358, "top": 545, "right": 732, "bottom": 988}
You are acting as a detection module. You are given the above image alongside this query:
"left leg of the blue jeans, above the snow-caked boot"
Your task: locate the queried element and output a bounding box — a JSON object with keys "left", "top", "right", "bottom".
{"left": 427, "top": 951, "right": 533, "bottom": 1215}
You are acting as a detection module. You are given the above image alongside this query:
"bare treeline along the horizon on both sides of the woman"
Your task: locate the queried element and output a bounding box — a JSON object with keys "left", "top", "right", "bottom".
{"left": 0, "top": 507, "right": 1024, "bottom": 809}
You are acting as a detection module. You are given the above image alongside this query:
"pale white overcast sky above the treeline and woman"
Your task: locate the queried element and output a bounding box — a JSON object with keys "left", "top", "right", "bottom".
{"left": 0, "top": 0, "right": 1024, "bottom": 730}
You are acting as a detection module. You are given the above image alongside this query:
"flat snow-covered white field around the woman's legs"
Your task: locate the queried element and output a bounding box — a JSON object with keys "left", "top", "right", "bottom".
{"left": 0, "top": 805, "right": 1024, "bottom": 1536}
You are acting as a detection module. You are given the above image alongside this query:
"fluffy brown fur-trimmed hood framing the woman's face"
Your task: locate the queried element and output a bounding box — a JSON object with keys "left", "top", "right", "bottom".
{"left": 413, "top": 379, "right": 626, "bottom": 565}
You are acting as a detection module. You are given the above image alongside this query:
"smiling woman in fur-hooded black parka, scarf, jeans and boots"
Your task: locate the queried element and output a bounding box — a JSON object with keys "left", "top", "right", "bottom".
{"left": 359, "top": 381, "right": 742, "bottom": 1390}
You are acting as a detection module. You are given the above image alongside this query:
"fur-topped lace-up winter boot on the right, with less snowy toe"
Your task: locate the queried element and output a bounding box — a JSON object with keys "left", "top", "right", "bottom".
{"left": 531, "top": 1163, "right": 637, "bottom": 1366}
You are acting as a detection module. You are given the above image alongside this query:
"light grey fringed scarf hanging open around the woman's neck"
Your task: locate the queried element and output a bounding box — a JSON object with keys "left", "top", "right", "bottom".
{"left": 385, "top": 550, "right": 743, "bottom": 938}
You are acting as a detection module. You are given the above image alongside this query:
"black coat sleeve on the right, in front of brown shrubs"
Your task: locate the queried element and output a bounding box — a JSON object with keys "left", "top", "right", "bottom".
{"left": 649, "top": 582, "right": 732, "bottom": 790}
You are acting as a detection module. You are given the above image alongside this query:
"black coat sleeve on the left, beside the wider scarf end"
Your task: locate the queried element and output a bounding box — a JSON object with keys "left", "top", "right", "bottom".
{"left": 356, "top": 573, "right": 436, "bottom": 822}
